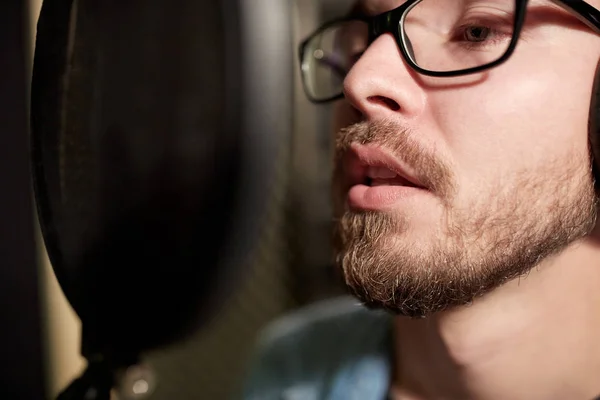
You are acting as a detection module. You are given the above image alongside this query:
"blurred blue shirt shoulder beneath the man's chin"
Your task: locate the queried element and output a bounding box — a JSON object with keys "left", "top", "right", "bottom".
{"left": 242, "top": 297, "right": 392, "bottom": 400}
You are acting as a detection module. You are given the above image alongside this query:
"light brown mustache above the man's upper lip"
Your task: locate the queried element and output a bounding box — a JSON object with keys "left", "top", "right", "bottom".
{"left": 334, "top": 120, "right": 455, "bottom": 199}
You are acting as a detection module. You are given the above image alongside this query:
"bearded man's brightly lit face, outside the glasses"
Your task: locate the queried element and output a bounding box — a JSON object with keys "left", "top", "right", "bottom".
{"left": 334, "top": 0, "right": 600, "bottom": 316}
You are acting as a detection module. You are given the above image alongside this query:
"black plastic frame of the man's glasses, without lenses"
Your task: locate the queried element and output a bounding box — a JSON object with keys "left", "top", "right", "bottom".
{"left": 299, "top": 0, "right": 600, "bottom": 103}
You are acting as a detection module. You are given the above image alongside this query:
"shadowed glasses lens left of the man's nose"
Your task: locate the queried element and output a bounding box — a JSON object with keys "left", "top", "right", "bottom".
{"left": 302, "top": 20, "right": 369, "bottom": 100}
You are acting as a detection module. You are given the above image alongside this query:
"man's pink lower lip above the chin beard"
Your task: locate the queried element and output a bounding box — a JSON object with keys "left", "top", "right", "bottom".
{"left": 348, "top": 185, "right": 425, "bottom": 211}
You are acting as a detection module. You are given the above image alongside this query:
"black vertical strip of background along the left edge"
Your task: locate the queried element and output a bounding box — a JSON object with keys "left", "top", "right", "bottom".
{"left": 0, "top": 0, "right": 44, "bottom": 400}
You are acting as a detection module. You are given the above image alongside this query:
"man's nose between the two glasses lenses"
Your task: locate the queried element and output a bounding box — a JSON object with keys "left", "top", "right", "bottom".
{"left": 344, "top": 34, "right": 426, "bottom": 120}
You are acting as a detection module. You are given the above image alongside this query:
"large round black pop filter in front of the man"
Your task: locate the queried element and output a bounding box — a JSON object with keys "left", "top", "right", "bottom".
{"left": 31, "top": 0, "right": 292, "bottom": 398}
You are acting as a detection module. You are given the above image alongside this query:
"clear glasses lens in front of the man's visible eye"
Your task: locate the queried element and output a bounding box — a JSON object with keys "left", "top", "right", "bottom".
{"left": 400, "top": 0, "right": 516, "bottom": 72}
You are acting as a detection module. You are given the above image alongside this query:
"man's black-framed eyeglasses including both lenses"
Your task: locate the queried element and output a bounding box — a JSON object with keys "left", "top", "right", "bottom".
{"left": 300, "top": 0, "right": 600, "bottom": 103}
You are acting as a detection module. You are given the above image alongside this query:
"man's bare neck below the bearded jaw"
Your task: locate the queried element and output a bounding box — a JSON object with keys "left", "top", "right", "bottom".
{"left": 392, "top": 239, "right": 600, "bottom": 400}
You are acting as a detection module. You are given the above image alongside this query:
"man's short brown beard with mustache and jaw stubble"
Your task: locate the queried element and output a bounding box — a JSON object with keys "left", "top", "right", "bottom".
{"left": 333, "top": 122, "right": 596, "bottom": 317}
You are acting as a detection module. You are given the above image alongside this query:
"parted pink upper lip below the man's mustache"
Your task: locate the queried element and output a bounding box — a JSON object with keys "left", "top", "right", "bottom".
{"left": 345, "top": 143, "right": 424, "bottom": 188}
